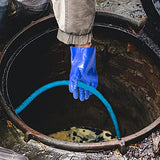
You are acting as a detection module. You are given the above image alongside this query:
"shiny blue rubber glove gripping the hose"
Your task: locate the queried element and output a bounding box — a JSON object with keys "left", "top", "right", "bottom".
{"left": 69, "top": 47, "right": 98, "bottom": 101}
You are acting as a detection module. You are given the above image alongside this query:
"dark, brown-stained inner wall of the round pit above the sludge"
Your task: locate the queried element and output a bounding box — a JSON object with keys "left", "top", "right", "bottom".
{"left": 4, "top": 27, "right": 160, "bottom": 142}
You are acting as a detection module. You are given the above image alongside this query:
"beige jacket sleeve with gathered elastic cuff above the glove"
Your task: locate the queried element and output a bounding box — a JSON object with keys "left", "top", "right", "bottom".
{"left": 52, "top": 0, "right": 95, "bottom": 44}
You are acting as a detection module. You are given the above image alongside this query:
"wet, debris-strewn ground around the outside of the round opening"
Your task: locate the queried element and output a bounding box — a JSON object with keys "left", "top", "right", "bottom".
{"left": 0, "top": 0, "right": 160, "bottom": 160}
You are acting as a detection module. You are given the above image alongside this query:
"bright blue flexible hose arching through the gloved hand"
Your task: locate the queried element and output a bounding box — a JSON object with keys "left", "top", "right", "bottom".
{"left": 15, "top": 80, "right": 121, "bottom": 138}
